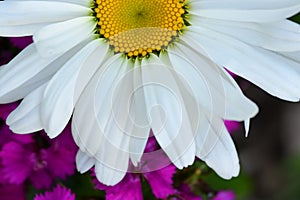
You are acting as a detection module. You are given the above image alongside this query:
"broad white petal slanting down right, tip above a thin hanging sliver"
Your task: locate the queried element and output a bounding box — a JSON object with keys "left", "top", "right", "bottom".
{"left": 169, "top": 42, "right": 258, "bottom": 121}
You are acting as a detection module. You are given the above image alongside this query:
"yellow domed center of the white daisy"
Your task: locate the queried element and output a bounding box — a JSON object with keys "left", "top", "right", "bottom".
{"left": 95, "top": 0, "right": 185, "bottom": 57}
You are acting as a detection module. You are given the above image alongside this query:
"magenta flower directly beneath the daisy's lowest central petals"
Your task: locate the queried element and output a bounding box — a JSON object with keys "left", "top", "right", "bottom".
{"left": 92, "top": 137, "right": 176, "bottom": 200}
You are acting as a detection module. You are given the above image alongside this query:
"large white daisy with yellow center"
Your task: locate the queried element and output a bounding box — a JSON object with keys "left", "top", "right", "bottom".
{"left": 0, "top": 0, "right": 300, "bottom": 185}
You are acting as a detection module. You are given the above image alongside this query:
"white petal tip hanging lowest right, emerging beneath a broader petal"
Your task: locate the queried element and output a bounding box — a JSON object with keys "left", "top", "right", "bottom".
{"left": 196, "top": 115, "right": 240, "bottom": 179}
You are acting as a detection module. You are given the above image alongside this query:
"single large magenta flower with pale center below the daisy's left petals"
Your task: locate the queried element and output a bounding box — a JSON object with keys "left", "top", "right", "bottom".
{"left": 0, "top": 126, "right": 77, "bottom": 189}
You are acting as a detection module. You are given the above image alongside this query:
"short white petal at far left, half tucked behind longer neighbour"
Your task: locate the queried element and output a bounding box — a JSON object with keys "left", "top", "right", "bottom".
{"left": 6, "top": 84, "right": 46, "bottom": 134}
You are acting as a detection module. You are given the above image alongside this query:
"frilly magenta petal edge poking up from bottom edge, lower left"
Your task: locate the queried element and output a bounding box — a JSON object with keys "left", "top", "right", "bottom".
{"left": 34, "top": 185, "right": 75, "bottom": 200}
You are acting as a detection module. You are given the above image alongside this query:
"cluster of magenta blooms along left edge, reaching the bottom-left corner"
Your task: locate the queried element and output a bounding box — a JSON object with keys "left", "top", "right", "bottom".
{"left": 0, "top": 104, "right": 77, "bottom": 200}
